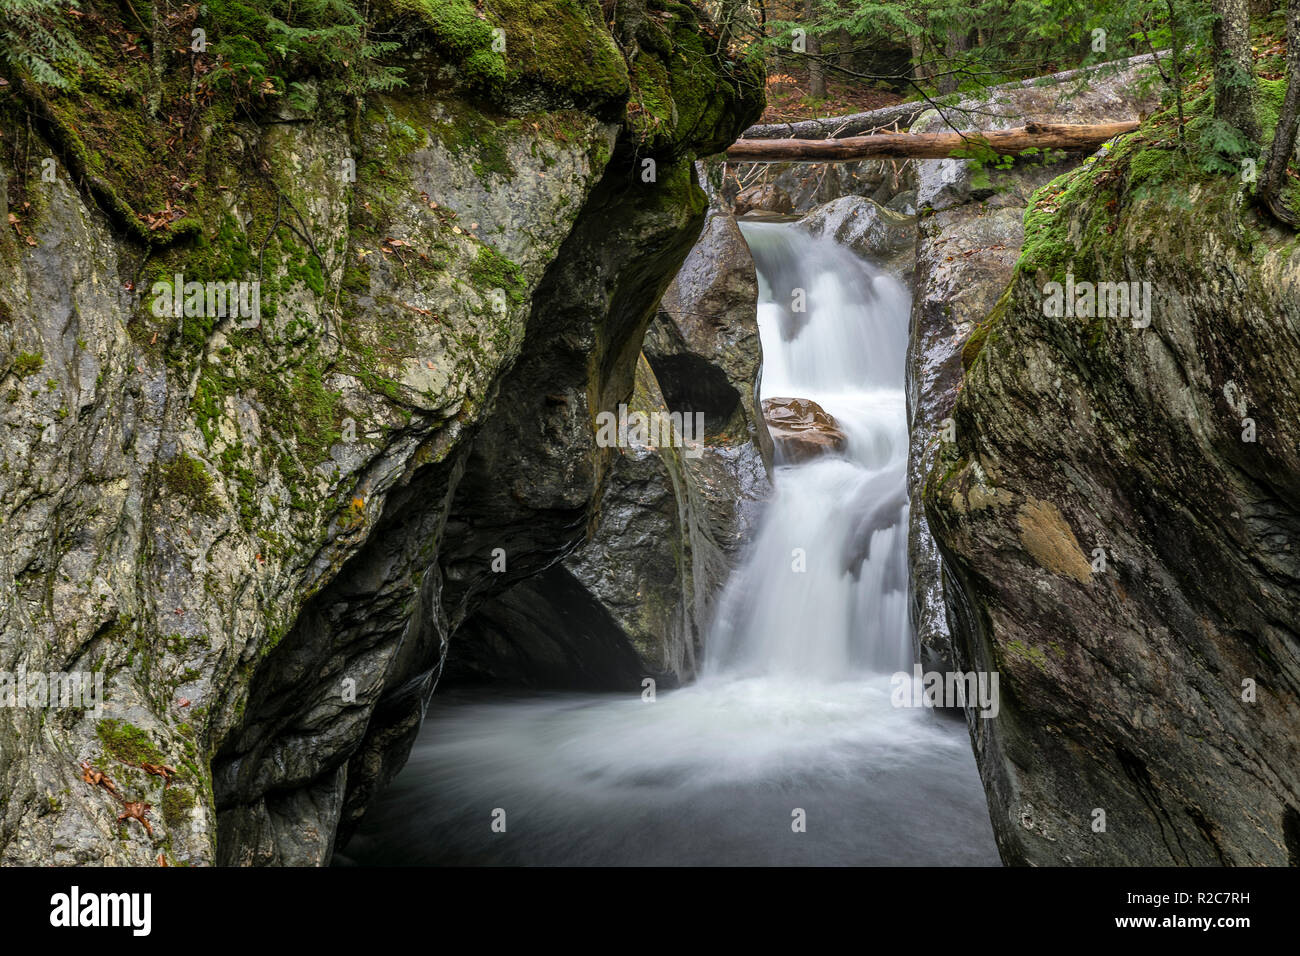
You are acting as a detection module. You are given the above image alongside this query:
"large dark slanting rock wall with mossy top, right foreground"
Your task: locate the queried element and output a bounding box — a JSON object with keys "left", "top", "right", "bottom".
{"left": 924, "top": 130, "right": 1300, "bottom": 865}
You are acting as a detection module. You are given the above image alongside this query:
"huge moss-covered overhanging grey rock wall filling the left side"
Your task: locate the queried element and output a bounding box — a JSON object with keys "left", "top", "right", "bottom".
{"left": 0, "top": 0, "right": 762, "bottom": 865}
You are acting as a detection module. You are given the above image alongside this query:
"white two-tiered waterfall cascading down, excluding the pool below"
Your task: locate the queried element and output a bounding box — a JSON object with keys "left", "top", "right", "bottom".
{"left": 705, "top": 222, "right": 911, "bottom": 680}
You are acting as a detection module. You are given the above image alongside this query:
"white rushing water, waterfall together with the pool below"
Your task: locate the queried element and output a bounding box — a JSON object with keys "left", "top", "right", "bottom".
{"left": 341, "top": 224, "right": 997, "bottom": 865}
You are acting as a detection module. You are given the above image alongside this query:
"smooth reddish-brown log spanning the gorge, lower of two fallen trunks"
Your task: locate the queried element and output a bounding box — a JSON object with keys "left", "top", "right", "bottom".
{"left": 727, "top": 120, "right": 1138, "bottom": 163}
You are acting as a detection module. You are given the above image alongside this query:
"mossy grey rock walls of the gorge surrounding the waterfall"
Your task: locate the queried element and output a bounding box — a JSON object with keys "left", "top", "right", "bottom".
{"left": 0, "top": 0, "right": 1300, "bottom": 865}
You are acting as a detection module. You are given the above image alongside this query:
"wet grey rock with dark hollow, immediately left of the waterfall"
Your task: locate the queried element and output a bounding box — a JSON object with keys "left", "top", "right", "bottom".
{"left": 449, "top": 195, "right": 771, "bottom": 688}
